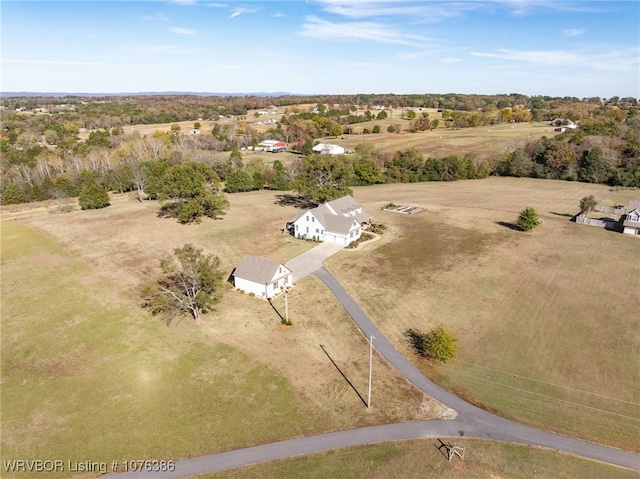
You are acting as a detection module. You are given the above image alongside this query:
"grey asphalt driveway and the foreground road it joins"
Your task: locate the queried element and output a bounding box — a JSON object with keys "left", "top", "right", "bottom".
{"left": 107, "top": 267, "right": 640, "bottom": 479}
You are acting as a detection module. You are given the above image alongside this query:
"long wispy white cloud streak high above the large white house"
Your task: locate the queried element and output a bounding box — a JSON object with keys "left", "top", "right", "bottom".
{"left": 299, "top": 16, "right": 429, "bottom": 47}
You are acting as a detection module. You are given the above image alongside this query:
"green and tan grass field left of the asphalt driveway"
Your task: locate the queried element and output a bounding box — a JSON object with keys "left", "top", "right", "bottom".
{"left": 0, "top": 192, "right": 450, "bottom": 477}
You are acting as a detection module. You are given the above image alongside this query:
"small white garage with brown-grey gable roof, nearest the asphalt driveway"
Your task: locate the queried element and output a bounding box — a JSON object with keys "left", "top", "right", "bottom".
{"left": 231, "top": 255, "right": 293, "bottom": 299}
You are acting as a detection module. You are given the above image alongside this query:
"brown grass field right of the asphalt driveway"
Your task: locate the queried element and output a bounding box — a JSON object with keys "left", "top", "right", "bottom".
{"left": 328, "top": 178, "right": 640, "bottom": 450}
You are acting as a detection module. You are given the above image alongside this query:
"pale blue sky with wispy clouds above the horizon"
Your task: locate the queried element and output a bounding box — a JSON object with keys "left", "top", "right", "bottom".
{"left": 0, "top": 0, "right": 640, "bottom": 98}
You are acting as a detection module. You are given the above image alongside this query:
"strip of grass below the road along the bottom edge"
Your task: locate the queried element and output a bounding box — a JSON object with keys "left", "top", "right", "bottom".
{"left": 206, "top": 438, "right": 637, "bottom": 479}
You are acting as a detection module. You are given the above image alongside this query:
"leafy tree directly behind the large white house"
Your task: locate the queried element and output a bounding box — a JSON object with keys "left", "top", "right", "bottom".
{"left": 293, "top": 155, "right": 353, "bottom": 203}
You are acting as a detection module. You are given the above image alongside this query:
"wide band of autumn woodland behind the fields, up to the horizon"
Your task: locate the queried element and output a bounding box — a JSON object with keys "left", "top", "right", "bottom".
{"left": 0, "top": 94, "right": 640, "bottom": 207}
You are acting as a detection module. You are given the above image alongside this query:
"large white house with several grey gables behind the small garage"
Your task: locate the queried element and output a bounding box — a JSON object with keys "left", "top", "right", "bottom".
{"left": 287, "top": 195, "right": 371, "bottom": 246}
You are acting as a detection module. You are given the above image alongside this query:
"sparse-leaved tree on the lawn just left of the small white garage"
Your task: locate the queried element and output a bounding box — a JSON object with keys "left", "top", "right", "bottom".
{"left": 142, "top": 244, "right": 224, "bottom": 324}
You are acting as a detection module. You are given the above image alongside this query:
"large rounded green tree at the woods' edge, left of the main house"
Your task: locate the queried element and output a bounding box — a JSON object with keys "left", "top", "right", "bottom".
{"left": 158, "top": 162, "right": 229, "bottom": 223}
